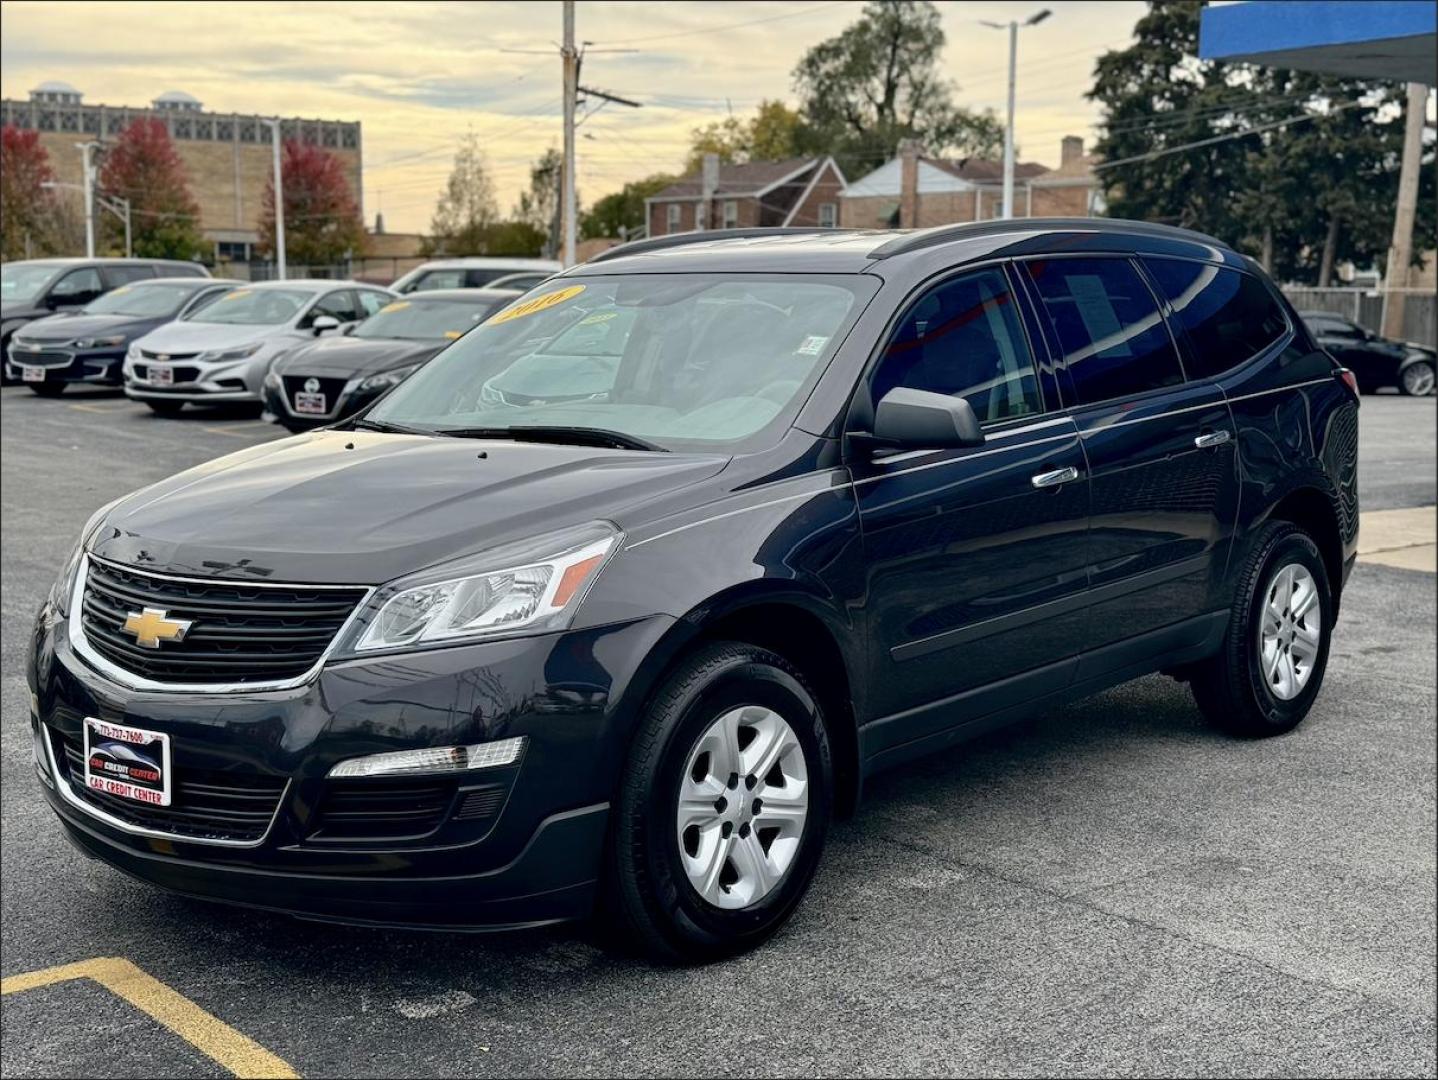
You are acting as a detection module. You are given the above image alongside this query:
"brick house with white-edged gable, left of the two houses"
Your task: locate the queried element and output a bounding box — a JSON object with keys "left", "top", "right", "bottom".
{"left": 644, "top": 154, "right": 844, "bottom": 236}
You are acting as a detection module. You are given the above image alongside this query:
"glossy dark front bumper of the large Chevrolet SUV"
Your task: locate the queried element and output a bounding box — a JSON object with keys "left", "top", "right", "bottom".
{"left": 29, "top": 601, "right": 672, "bottom": 929}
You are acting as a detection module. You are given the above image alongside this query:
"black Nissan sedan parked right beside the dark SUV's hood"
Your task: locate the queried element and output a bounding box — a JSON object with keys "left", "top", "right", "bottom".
{"left": 265, "top": 289, "right": 523, "bottom": 431}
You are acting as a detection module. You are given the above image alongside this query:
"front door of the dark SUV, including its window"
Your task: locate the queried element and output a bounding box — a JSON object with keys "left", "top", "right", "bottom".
{"left": 853, "top": 266, "right": 1089, "bottom": 755}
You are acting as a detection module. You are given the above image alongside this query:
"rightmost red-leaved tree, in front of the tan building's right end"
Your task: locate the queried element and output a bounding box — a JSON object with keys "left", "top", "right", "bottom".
{"left": 260, "top": 139, "right": 364, "bottom": 266}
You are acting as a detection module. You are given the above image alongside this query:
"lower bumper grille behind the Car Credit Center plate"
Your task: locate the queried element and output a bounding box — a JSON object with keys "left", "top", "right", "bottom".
{"left": 50, "top": 729, "right": 285, "bottom": 843}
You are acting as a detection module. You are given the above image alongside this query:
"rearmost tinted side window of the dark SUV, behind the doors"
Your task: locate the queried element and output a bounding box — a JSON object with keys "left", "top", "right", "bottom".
{"left": 1143, "top": 259, "right": 1288, "bottom": 378}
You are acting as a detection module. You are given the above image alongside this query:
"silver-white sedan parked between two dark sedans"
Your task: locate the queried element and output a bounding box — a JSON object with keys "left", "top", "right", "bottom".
{"left": 125, "top": 280, "right": 394, "bottom": 416}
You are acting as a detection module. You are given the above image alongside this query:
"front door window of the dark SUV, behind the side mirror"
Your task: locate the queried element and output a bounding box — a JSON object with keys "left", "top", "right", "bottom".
{"left": 873, "top": 270, "right": 1043, "bottom": 421}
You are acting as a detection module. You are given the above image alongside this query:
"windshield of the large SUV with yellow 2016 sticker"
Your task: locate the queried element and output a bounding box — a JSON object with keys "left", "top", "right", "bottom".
{"left": 367, "top": 273, "right": 876, "bottom": 449}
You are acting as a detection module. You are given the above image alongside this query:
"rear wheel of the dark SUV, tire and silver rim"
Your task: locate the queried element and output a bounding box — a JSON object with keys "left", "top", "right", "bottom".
{"left": 1191, "top": 522, "right": 1334, "bottom": 738}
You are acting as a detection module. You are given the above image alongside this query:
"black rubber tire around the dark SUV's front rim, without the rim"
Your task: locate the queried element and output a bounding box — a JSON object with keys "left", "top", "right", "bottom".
{"left": 604, "top": 643, "right": 834, "bottom": 964}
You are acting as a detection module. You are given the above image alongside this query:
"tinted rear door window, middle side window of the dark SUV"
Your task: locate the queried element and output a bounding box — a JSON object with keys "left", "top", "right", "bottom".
{"left": 1028, "top": 259, "right": 1183, "bottom": 404}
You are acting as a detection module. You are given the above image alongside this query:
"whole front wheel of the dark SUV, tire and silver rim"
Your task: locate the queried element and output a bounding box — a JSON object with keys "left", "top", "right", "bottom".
{"left": 607, "top": 643, "right": 833, "bottom": 964}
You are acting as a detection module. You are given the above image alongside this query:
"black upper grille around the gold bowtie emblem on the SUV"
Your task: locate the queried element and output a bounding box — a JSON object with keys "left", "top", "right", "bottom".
{"left": 81, "top": 559, "right": 365, "bottom": 683}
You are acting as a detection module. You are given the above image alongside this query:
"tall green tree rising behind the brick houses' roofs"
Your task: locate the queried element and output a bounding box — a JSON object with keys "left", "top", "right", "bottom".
{"left": 794, "top": 0, "right": 1004, "bottom": 173}
